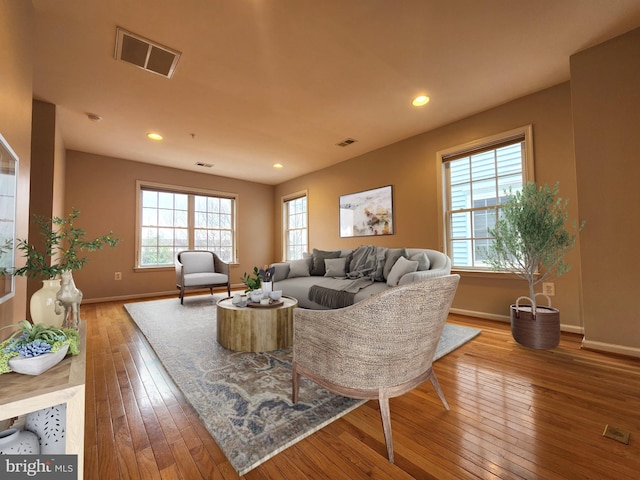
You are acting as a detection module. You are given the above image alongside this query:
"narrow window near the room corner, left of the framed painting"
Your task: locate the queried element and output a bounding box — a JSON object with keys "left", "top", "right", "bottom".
{"left": 282, "top": 192, "right": 309, "bottom": 261}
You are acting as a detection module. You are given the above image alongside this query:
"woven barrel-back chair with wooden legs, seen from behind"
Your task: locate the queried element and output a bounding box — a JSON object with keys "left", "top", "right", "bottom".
{"left": 292, "top": 275, "right": 460, "bottom": 463}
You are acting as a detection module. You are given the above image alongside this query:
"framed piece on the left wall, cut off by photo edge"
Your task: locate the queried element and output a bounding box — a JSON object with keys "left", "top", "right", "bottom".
{"left": 0, "top": 135, "right": 18, "bottom": 303}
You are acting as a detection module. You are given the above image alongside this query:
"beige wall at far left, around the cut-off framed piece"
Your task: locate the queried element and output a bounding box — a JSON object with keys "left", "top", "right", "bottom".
{"left": 0, "top": 0, "right": 33, "bottom": 330}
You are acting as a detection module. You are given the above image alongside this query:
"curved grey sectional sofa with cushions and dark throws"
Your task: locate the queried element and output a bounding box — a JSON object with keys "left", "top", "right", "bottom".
{"left": 272, "top": 245, "right": 451, "bottom": 310}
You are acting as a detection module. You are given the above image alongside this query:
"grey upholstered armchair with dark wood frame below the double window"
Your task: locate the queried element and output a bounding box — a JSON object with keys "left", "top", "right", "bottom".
{"left": 175, "top": 250, "right": 231, "bottom": 304}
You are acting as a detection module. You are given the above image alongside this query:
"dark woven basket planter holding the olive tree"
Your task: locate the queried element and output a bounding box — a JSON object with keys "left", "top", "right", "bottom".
{"left": 511, "top": 304, "right": 560, "bottom": 350}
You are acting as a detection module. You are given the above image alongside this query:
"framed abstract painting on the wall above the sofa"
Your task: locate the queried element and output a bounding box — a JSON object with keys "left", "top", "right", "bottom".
{"left": 340, "top": 185, "right": 393, "bottom": 237}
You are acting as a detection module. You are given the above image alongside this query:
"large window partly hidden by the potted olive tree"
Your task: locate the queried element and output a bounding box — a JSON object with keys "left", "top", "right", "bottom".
{"left": 438, "top": 126, "right": 533, "bottom": 270}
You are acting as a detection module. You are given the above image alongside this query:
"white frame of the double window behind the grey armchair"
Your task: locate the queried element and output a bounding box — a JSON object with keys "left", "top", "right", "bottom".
{"left": 135, "top": 180, "right": 238, "bottom": 270}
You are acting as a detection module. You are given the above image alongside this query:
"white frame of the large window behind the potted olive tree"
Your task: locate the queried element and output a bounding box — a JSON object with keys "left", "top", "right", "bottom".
{"left": 436, "top": 125, "right": 535, "bottom": 272}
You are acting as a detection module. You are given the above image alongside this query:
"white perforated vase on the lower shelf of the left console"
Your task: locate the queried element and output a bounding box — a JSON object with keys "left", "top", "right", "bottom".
{"left": 24, "top": 403, "right": 67, "bottom": 455}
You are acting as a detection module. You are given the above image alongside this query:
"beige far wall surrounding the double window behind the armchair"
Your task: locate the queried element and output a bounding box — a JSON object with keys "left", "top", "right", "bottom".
{"left": 65, "top": 151, "right": 274, "bottom": 301}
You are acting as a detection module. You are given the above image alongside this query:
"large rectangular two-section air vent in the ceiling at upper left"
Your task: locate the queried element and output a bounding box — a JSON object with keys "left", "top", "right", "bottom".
{"left": 114, "top": 27, "right": 181, "bottom": 78}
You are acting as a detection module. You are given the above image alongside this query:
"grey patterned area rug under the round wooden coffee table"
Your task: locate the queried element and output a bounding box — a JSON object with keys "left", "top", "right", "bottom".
{"left": 125, "top": 295, "right": 480, "bottom": 475}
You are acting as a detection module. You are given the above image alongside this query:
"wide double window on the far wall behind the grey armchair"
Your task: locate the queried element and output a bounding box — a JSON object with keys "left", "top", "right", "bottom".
{"left": 137, "top": 182, "right": 236, "bottom": 267}
